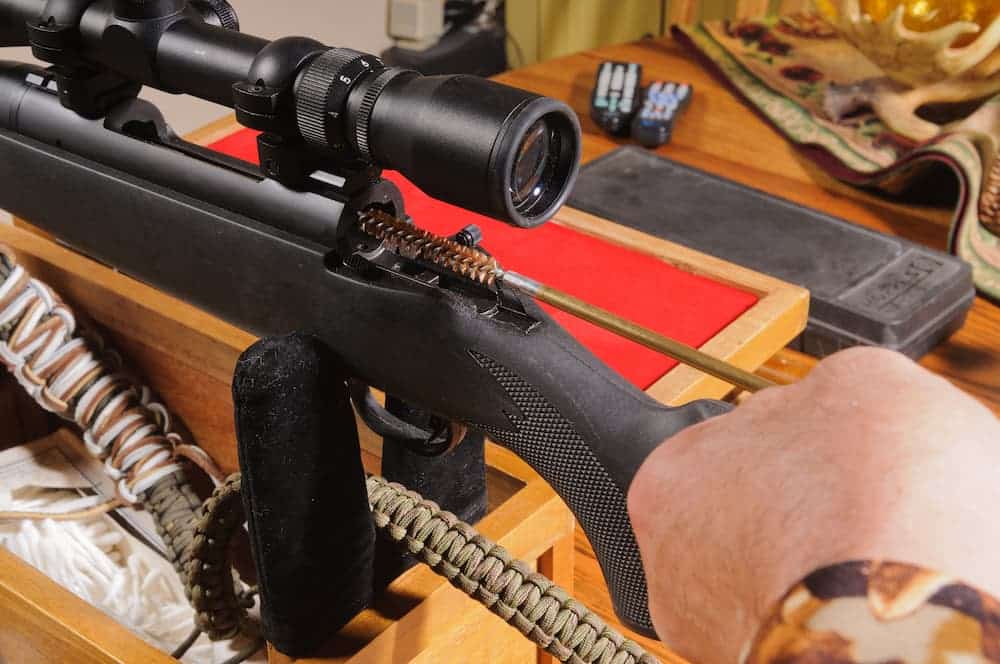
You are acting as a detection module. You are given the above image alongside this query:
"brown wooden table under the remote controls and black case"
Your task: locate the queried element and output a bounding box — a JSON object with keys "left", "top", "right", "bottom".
{"left": 499, "top": 32, "right": 1000, "bottom": 661}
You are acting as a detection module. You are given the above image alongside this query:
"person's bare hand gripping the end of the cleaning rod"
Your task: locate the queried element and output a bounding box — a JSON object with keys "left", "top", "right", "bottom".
{"left": 629, "top": 348, "right": 1000, "bottom": 664}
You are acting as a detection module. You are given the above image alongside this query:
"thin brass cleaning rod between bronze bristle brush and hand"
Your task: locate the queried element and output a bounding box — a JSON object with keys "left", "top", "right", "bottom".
{"left": 502, "top": 271, "right": 775, "bottom": 392}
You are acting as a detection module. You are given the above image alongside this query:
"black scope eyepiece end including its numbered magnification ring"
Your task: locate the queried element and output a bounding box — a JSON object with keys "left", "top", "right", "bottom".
{"left": 295, "top": 49, "right": 580, "bottom": 227}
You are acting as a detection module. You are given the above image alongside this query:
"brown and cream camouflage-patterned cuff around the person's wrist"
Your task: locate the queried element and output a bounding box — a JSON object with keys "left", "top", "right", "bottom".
{"left": 742, "top": 561, "right": 1000, "bottom": 664}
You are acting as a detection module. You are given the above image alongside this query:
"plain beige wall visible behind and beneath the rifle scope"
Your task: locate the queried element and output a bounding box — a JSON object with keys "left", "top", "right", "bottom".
{"left": 0, "top": 0, "right": 390, "bottom": 134}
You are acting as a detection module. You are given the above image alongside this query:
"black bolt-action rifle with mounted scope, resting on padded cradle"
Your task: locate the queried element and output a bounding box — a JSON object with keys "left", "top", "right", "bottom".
{"left": 0, "top": 0, "right": 727, "bottom": 635}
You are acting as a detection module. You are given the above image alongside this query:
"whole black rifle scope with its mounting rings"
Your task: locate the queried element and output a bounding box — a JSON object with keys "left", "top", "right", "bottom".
{"left": 0, "top": 0, "right": 580, "bottom": 227}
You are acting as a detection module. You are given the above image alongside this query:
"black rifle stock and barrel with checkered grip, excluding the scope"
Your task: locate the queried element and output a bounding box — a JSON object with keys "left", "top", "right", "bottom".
{"left": 0, "top": 58, "right": 726, "bottom": 634}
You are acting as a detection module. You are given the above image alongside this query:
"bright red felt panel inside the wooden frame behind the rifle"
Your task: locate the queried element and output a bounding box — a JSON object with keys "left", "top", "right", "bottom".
{"left": 211, "top": 130, "right": 757, "bottom": 389}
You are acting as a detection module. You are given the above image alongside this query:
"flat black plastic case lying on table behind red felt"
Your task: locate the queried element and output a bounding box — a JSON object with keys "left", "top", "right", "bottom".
{"left": 569, "top": 147, "right": 975, "bottom": 357}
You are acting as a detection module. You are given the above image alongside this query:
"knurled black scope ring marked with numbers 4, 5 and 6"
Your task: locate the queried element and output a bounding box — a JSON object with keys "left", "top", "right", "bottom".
{"left": 295, "top": 48, "right": 385, "bottom": 150}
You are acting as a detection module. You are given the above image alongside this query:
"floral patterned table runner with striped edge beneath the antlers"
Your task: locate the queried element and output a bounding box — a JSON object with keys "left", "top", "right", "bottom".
{"left": 674, "top": 14, "right": 1000, "bottom": 300}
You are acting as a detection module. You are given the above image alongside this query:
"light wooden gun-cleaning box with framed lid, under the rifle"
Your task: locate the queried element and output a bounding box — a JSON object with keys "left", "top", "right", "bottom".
{"left": 0, "top": 124, "right": 808, "bottom": 664}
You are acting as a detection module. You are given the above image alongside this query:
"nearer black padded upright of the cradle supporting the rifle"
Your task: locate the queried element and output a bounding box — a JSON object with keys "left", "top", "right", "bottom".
{"left": 233, "top": 334, "right": 375, "bottom": 657}
